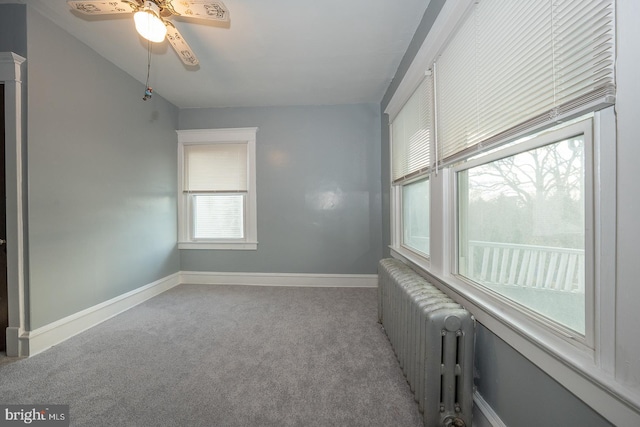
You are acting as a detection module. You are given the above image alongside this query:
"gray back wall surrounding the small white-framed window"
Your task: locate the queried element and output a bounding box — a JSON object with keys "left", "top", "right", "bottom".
{"left": 179, "top": 105, "right": 382, "bottom": 274}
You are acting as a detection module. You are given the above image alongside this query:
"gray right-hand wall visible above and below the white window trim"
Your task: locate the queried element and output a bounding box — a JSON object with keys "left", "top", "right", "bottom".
{"left": 380, "top": 0, "right": 612, "bottom": 427}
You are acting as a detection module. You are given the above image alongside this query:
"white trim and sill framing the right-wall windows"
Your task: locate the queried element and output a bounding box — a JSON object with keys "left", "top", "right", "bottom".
{"left": 384, "top": 0, "right": 640, "bottom": 425}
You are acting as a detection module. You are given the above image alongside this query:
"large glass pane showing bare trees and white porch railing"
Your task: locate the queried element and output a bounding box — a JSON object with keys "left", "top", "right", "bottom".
{"left": 458, "top": 136, "right": 585, "bottom": 334}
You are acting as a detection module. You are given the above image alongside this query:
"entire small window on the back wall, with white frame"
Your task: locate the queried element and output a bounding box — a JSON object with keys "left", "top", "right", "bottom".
{"left": 178, "top": 128, "right": 258, "bottom": 249}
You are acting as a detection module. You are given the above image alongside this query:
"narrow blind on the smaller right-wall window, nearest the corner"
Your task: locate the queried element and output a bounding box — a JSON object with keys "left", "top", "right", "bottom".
{"left": 391, "top": 76, "right": 434, "bottom": 184}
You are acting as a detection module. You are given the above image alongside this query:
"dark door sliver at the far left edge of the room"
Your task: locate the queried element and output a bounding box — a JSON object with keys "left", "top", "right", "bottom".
{"left": 0, "top": 83, "right": 9, "bottom": 352}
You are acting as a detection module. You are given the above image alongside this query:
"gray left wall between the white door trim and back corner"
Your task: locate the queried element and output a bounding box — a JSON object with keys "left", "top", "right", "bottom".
{"left": 26, "top": 8, "right": 180, "bottom": 329}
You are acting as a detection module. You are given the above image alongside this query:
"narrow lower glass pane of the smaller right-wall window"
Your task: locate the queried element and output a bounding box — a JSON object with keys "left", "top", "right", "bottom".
{"left": 402, "top": 179, "right": 429, "bottom": 255}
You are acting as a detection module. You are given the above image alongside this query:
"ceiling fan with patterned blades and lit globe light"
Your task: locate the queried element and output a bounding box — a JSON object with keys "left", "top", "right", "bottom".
{"left": 67, "top": 0, "right": 229, "bottom": 65}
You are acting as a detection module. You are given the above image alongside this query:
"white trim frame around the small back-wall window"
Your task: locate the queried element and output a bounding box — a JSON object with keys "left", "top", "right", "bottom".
{"left": 176, "top": 127, "right": 258, "bottom": 250}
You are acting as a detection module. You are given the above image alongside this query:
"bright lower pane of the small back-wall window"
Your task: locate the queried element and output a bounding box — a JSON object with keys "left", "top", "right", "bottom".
{"left": 192, "top": 194, "right": 244, "bottom": 239}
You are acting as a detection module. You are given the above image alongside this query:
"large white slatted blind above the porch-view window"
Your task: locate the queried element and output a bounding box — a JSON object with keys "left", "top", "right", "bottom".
{"left": 435, "top": 0, "right": 615, "bottom": 164}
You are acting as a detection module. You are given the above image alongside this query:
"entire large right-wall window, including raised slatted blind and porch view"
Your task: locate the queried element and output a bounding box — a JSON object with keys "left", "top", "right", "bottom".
{"left": 433, "top": 0, "right": 615, "bottom": 348}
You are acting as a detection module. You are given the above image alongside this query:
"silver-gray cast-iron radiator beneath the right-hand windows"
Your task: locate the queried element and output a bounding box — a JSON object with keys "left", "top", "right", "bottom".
{"left": 378, "top": 259, "right": 475, "bottom": 427}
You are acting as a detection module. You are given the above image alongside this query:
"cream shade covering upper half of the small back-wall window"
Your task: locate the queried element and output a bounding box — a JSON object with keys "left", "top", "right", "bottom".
{"left": 183, "top": 143, "right": 248, "bottom": 193}
